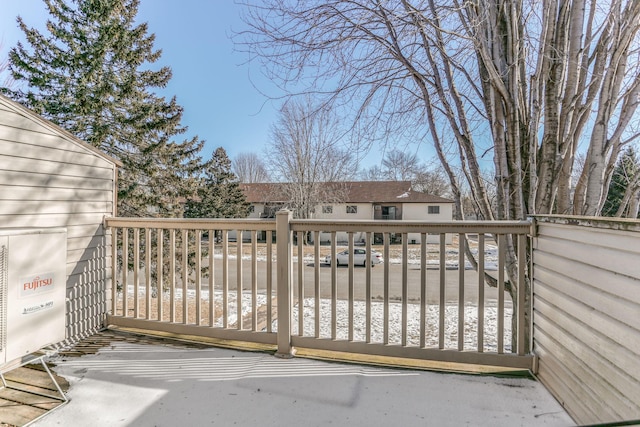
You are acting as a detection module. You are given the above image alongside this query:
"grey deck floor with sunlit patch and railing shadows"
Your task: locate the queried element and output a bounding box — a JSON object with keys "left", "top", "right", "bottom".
{"left": 31, "top": 331, "right": 575, "bottom": 427}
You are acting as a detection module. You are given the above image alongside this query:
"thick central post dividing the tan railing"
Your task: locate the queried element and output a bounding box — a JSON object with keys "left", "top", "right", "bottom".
{"left": 276, "top": 209, "right": 295, "bottom": 359}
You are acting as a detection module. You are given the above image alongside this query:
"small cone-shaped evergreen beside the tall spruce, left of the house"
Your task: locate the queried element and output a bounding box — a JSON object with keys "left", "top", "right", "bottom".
{"left": 185, "top": 147, "right": 250, "bottom": 218}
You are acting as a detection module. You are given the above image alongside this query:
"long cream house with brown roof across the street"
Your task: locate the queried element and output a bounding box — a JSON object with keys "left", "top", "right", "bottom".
{"left": 242, "top": 181, "right": 453, "bottom": 243}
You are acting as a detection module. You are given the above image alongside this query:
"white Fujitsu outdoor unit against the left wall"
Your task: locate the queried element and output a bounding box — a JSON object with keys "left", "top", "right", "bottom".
{"left": 0, "top": 228, "right": 67, "bottom": 371}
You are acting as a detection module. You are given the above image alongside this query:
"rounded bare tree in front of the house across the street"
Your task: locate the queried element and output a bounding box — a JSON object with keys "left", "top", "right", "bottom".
{"left": 267, "top": 97, "right": 357, "bottom": 218}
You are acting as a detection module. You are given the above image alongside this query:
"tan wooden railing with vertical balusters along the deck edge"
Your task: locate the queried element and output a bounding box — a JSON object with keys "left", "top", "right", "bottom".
{"left": 106, "top": 211, "right": 533, "bottom": 369}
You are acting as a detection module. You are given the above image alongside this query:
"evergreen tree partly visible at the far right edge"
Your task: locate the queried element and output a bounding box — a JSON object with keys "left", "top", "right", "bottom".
{"left": 602, "top": 146, "right": 640, "bottom": 217}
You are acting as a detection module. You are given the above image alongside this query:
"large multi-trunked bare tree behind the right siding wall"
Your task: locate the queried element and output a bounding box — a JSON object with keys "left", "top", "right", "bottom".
{"left": 240, "top": 0, "right": 640, "bottom": 348}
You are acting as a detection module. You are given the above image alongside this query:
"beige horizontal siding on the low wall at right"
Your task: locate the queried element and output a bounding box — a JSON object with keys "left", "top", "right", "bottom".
{"left": 533, "top": 218, "right": 640, "bottom": 424}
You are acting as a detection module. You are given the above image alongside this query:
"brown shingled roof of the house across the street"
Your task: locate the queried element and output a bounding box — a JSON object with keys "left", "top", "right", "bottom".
{"left": 241, "top": 181, "right": 453, "bottom": 203}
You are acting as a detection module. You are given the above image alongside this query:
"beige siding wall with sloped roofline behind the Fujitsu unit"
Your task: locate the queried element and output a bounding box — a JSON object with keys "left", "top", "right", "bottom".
{"left": 0, "top": 95, "right": 121, "bottom": 348}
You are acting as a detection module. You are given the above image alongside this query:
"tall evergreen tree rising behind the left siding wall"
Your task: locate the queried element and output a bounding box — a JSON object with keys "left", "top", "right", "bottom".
{"left": 5, "top": 0, "right": 203, "bottom": 216}
